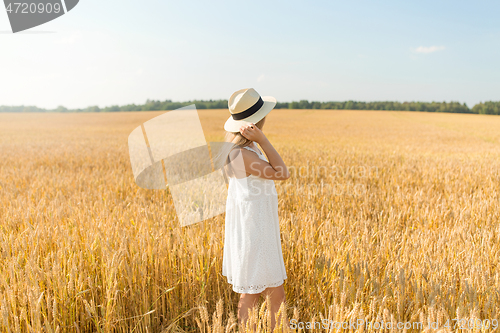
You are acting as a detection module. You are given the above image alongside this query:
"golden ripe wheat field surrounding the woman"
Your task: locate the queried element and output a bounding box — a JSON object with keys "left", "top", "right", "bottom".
{"left": 0, "top": 109, "right": 500, "bottom": 332}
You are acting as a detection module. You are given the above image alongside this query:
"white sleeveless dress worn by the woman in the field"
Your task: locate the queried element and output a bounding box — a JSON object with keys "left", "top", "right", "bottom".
{"left": 222, "top": 147, "right": 287, "bottom": 294}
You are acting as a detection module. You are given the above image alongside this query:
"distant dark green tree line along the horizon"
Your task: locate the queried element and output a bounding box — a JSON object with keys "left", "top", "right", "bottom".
{"left": 0, "top": 99, "right": 500, "bottom": 115}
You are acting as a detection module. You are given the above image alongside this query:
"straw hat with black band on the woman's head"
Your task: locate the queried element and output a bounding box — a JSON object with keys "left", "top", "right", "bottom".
{"left": 224, "top": 88, "right": 276, "bottom": 132}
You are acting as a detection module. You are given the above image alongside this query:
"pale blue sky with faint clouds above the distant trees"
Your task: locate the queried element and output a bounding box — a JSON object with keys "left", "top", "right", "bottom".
{"left": 0, "top": 0, "right": 500, "bottom": 108}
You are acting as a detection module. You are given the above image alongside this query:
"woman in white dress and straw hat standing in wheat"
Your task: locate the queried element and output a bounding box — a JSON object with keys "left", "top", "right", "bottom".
{"left": 222, "top": 88, "right": 290, "bottom": 328}
